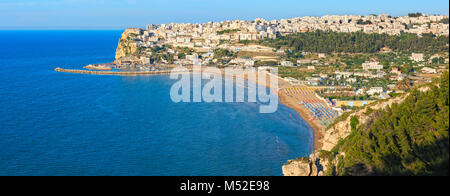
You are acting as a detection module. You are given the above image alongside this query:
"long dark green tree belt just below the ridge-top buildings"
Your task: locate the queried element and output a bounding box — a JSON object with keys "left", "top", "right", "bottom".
{"left": 258, "top": 30, "right": 449, "bottom": 54}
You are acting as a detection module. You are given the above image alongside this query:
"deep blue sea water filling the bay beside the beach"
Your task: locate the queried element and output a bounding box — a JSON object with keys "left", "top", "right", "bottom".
{"left": 0, "top": 31, "right": 312, "bottom": 176}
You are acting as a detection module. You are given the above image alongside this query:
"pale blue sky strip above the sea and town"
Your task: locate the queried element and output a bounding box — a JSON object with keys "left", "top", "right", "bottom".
{"left": 0, "top": 0, "right": 449, "bottom": 30}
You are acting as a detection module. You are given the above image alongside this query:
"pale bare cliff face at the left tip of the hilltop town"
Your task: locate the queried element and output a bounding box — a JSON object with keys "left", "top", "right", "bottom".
{"left": 116, "top": 28, "right": 141, "bottom": 61}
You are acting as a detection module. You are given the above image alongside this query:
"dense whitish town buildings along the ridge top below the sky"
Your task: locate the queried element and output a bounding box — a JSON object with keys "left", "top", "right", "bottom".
{"left": 116, "top": 13, "right": 449, "bottom": 65}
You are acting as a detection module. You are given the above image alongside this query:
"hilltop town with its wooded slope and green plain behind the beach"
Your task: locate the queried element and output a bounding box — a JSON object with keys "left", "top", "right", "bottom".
{"left": 108, "top": 13, "right": 449, "bottom": 127}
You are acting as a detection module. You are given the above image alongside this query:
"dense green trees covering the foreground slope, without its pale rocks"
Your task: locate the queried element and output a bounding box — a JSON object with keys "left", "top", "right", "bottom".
{"left": 334, "top": 72, "right": 449, "bottom": 175}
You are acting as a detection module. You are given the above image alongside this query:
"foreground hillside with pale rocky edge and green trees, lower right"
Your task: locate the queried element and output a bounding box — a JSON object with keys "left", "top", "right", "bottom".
{"left": 283, "top": 73, "right": 449, "bottom": 175}
